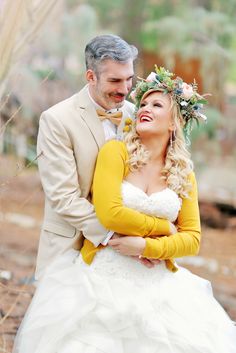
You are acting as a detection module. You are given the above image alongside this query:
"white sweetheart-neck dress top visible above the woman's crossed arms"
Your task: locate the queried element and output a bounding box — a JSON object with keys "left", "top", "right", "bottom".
{"left": 122, "top": 180, "right": 181, "bottom": 222}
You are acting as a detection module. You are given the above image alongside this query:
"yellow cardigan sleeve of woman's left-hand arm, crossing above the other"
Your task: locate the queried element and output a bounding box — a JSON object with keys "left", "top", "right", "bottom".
{"left": 93, "top": 140, "right": 170, "bottom": 237}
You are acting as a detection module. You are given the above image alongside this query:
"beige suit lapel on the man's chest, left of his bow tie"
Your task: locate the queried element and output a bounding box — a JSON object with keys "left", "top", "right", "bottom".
{"left": 77, "top": 86, "right": 105, "bottom": 149}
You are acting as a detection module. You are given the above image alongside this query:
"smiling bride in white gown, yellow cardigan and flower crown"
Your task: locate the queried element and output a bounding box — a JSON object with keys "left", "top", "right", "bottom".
{"left": 13, "top": 68, "right": 236, "bottom": 353}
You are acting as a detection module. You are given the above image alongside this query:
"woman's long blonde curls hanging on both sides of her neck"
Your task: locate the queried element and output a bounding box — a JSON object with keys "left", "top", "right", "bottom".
{"left": 124, "top": 96, "right": 193, "bottom": 198}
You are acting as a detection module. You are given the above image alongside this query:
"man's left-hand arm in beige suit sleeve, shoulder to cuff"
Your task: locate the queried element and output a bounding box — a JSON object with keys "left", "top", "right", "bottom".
{"left": 37, "top": 112, "right": 107, "bottom": 246}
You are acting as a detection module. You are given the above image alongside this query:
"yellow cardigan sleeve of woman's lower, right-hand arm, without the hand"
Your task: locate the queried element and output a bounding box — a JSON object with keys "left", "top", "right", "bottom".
{"left": 142, "top": 173, "right": 201, "bottom": 260}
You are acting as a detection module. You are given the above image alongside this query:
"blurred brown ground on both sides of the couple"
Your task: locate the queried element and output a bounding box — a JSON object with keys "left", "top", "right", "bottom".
{"left": 0, "top": 157, "right": 236, "bottom": 353}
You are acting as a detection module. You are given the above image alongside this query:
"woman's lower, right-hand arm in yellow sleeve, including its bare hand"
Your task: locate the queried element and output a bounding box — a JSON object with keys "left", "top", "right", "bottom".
{"left": 108, "top": 173, "right": 201, "bottom": 260}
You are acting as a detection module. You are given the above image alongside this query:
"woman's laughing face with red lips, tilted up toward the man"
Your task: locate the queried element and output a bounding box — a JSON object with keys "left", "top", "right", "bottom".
{"left": 136, "top": 92, "right": 173, "bottom": 139}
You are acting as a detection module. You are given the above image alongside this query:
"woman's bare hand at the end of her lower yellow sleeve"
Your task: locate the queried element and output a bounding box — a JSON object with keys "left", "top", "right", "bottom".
{"left": 108, "top": 237, "right": 146, "bottom": 256}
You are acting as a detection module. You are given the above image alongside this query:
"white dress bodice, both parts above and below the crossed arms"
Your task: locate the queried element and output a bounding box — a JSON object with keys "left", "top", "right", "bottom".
{"left": 85, "top": 181, "right": 181, "bottom": 286}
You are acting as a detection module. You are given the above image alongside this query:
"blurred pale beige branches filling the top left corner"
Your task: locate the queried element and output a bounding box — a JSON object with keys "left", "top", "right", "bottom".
{"left": 0, "top": 0, "right": 56, "bottom": 98}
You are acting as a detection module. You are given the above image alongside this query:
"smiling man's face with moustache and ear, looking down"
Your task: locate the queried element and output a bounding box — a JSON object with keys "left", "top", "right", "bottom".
{"left": 86, "top": 59, "right": 134, "bottom": 110}
